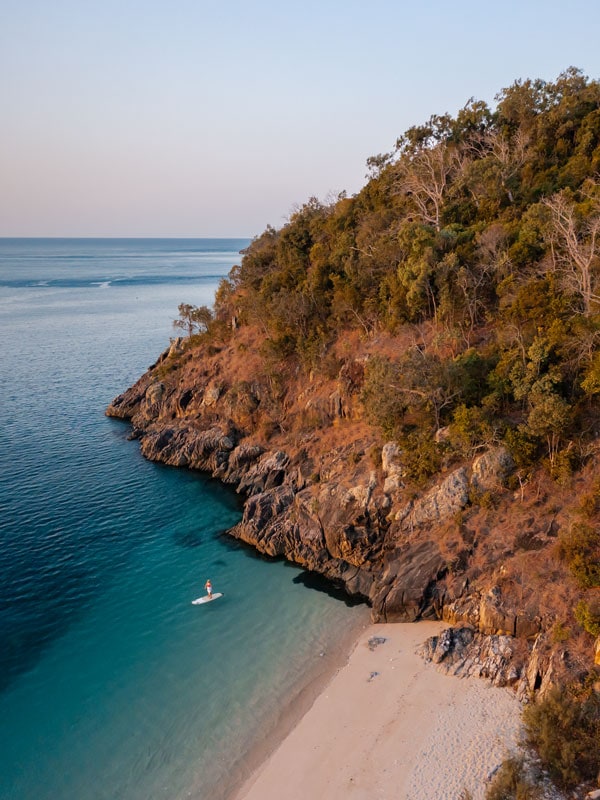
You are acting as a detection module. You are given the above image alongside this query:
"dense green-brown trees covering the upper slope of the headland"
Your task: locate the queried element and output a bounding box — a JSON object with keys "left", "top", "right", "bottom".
{"left": 204, "top": 68, "right": 600, "bottom": 494}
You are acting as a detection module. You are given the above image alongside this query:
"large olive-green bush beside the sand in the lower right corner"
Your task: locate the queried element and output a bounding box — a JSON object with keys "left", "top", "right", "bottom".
{"left": 523, "top": 689, "right": 600, "bottom": 788}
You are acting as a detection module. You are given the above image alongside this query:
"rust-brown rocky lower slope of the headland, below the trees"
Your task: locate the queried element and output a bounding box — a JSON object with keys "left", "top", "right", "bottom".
{"left": 107, "top": 330, "right": 593, "bottom": 697}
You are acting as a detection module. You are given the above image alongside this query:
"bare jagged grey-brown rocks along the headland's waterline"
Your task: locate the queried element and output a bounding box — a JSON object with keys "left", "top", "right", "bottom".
{"left": 107, "top": 362, "right": 568, "bottom": 691}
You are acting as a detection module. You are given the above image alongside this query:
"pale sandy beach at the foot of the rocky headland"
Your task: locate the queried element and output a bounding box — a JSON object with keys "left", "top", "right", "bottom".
{"left": 234, "top": 622, "right": 520, "bottom": 800}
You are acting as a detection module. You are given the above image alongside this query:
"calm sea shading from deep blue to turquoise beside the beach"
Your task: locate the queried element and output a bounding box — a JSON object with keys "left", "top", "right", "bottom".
{"left": 0, "top": 239, "right": 363, "bottom": 800}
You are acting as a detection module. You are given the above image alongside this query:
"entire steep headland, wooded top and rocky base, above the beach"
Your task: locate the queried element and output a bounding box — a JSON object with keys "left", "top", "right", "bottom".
{"left": 108, "top": 69, "right": 600, "bottom": 796}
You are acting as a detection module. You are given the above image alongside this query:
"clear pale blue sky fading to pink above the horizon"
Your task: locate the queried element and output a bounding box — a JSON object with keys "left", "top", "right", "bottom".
{"left": 0, "top": 0, "right": 600, "bottom": 236}
